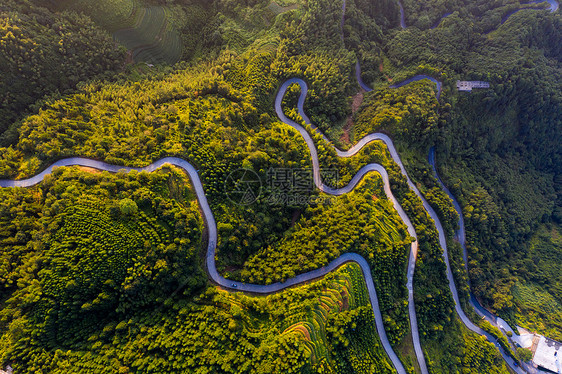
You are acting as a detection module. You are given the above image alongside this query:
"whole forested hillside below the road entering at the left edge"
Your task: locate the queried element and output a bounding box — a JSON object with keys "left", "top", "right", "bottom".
{"left": 0, "top": 168, "right": 392, "bottom": 373}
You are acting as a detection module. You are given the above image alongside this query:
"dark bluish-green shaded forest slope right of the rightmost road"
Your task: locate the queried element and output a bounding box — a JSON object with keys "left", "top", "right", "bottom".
{"left": 426, "top": 12, "right": 562, "bottom": 338}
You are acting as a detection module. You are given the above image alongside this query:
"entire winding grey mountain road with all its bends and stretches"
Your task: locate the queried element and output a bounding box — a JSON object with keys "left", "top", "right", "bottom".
{"left": 0, "top": 0, "right": 553, "bottom": 374}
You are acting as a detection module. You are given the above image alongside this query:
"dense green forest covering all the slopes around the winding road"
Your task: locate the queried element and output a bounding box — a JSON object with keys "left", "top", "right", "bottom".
{"left": 0, "top": 0, "right": 562, "bottom": 373}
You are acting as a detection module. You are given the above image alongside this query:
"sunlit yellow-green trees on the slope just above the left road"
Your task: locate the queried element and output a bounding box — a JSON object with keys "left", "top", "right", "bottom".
{"left": 0, "top": 68, "right": 249, "bottom": 176}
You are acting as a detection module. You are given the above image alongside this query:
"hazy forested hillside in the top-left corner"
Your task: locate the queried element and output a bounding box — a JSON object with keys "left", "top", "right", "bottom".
{"left": 0, "top": 0, "right": 125, "bottom": 139}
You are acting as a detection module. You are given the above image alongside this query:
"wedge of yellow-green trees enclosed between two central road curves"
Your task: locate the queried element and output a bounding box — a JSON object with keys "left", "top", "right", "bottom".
{"left": 240, "top": 174, "right": 410, "bottom": 283}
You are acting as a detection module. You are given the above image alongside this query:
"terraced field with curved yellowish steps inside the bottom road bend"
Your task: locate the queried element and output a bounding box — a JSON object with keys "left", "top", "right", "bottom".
{"left": 214, "top": 262, "right": 391, "bottom": 373}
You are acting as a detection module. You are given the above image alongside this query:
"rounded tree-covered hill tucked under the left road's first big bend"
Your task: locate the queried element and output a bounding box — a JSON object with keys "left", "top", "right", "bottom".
{"left": 0, "top": 167, "right": 205, "bottom": 354}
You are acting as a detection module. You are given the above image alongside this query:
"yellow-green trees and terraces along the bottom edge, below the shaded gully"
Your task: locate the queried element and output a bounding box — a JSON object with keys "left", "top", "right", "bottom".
{"left": 0, "top": 264, "right": 392, "bottom": 373}
